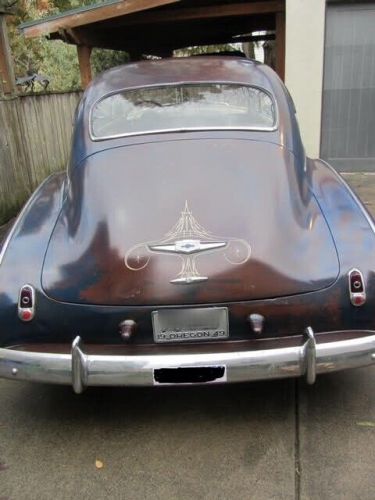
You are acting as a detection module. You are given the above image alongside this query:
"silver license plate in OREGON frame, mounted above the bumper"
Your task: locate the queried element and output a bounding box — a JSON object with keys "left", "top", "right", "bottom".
{"left": 152, "top": 307, "right": 229, "bottom": 343}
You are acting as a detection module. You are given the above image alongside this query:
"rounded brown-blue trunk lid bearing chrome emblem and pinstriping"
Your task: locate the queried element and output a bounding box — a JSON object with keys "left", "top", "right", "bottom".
{"left": 42, "top": 139, "right": 339, "bottom": 305}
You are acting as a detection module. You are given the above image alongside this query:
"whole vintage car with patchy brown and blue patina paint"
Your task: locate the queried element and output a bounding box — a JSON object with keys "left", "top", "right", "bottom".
{"left": 0, "top": 56, "right": 375, "bottom": 393}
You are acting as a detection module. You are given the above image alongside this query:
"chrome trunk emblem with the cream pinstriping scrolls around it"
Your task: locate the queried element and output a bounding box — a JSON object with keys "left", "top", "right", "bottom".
{"left": 125, "top": 202, "right": 251, "bottom": 284}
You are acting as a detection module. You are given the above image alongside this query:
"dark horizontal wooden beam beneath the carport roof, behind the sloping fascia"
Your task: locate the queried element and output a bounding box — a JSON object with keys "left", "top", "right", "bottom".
{"left": 100, "top": 0, "right": 285, "bottom": 26}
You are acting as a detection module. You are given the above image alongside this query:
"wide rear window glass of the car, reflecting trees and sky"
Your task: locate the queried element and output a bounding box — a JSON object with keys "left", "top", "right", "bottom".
{"left": 91, "top": 83, "right": 276, "bottom": 139}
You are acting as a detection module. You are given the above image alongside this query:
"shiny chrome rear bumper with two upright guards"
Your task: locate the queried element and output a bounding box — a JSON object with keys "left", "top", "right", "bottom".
{"left": 0, "top": 327, "right": 375, "bottom": 393}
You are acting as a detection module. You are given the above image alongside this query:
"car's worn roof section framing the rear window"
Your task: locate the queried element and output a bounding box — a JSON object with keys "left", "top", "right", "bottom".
{"left": 70, "top": 56, "right": 304, "bottom": 168}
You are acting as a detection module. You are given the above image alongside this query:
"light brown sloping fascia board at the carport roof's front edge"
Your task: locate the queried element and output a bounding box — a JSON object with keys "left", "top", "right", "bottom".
{"left": 20, "top": 0, "right": 180, "bottom": 38}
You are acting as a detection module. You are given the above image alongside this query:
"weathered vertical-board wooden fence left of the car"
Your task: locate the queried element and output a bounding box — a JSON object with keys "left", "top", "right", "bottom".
{"left": 0, "top": 92, "right": 81, "bottom": 225}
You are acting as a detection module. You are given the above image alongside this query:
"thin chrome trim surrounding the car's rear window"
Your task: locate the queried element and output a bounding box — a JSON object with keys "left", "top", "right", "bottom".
{"left": 88, "top": 81, "right": 279, "bottom": 142}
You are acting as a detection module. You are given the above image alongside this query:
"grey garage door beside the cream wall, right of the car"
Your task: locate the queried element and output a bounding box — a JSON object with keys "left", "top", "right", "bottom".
{"left": 321, "top": 2, "right": 375, "bottom": 172}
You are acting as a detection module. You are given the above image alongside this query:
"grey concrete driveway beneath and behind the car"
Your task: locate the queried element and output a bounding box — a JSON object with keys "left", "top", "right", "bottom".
{"left": 0, "top": 176, "right": 375, "bottom": 500}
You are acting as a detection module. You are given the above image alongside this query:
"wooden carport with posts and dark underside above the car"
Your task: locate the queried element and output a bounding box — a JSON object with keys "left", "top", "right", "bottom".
{"left": 20, "top": 0, "right": 285, "bottom": 87}
